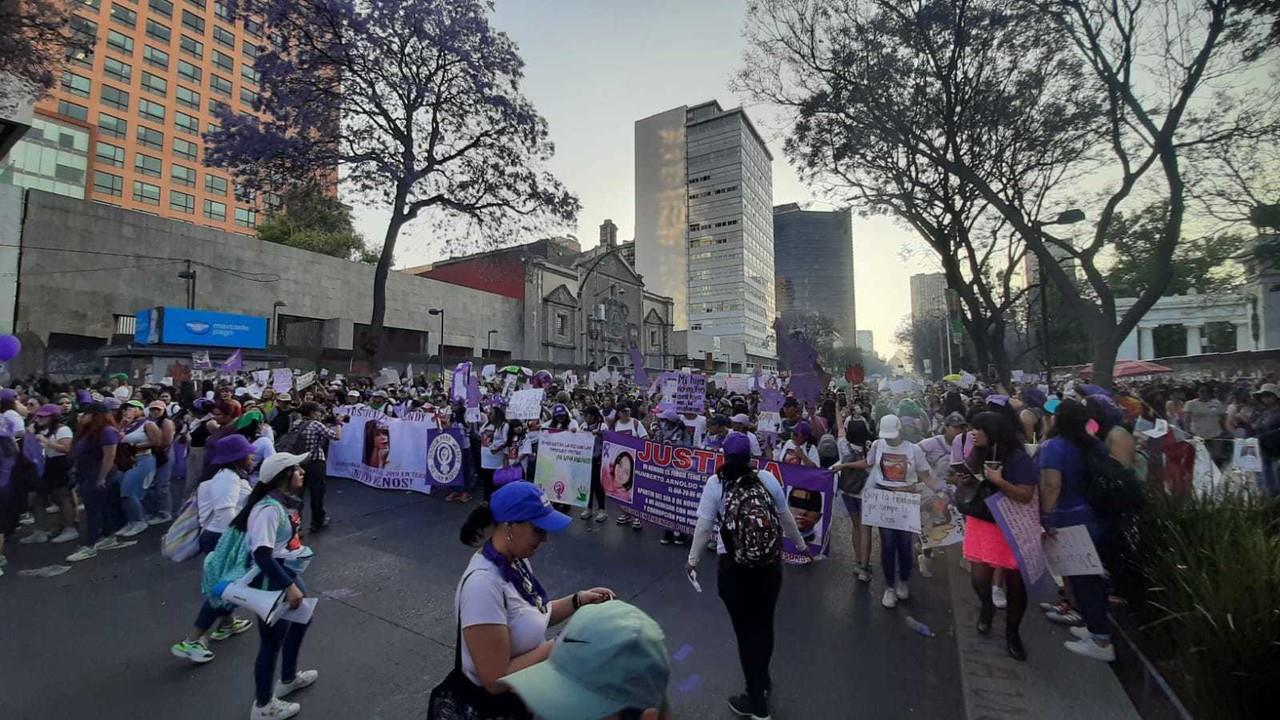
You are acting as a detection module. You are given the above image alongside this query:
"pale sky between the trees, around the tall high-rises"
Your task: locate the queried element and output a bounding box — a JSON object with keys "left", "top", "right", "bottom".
{"left": 352, "top": 0, "right": 938, "bottom": 357}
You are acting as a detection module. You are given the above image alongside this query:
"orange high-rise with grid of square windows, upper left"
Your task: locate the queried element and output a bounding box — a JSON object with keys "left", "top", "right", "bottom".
{"left": 0, "top": 0, "right": 274, "bottom": 233}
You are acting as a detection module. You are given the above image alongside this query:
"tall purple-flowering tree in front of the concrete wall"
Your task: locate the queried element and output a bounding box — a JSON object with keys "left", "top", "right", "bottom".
{"left": 209, "top": 0, "right": 579, "bottom": 356}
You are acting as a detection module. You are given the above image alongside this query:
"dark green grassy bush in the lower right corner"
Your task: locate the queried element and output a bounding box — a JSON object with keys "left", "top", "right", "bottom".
{"left": 1116, "top": 489, "right": 1280, "bottom": 719}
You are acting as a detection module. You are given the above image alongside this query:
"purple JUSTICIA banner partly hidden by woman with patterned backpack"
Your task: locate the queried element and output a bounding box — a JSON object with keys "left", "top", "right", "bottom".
{"left": 596, "top": 432, "right": 836, "bottom": 562}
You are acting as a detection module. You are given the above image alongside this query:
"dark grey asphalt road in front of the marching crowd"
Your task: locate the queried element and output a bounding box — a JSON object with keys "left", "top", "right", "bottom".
{"left": 0, "top": 480, "right": 964, "bottom": 720}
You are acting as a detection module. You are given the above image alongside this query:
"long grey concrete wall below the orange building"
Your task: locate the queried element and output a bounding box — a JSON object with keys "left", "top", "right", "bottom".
{"left": 12, "top": 188, "right": 524, "bottom": 355}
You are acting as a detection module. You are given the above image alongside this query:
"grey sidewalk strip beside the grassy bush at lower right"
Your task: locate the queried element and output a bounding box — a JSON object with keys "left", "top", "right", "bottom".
{"left": 943, "top": 546, "right": 1138, "bottom": 720}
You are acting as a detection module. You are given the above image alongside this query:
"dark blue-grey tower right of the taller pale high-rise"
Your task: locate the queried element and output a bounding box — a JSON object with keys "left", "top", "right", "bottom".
{"left": 773, "top": 202, "right": 858, "bottom": 341}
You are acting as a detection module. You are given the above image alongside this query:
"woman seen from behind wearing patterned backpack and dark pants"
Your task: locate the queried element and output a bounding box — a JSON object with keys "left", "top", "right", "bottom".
{"left": 685, "top": 433, "right": 808, "bottom": 720}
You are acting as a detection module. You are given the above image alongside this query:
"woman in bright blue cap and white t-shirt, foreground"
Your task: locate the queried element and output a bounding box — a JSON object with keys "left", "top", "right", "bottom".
{"left": 429, "top": 480, "right": 613, "bottom": 719}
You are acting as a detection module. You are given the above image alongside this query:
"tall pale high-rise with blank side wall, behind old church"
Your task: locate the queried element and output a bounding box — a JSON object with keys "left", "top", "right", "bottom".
{"left": 635, "top": 101, "right": 777, "bottom": 369}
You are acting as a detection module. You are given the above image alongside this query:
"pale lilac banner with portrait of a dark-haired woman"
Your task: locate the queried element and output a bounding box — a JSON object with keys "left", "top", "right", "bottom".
{"left": 326, "top": 406, "right": 435, "bottom": 492}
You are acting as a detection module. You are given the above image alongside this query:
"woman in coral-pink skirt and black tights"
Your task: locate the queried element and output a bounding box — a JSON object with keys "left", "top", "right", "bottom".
{"left": 961, "top": 413, "right": 1037, "bottom": 660}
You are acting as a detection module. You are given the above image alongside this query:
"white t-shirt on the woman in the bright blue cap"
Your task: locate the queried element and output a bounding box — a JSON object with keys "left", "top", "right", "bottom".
{"left": 454, "top": 552, "right": 552, "bottom": 685}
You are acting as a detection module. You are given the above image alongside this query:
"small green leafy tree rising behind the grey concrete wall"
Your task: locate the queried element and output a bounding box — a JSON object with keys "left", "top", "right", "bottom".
{"left": 257, "top": 183, "right": 379, "bottom": 264}
